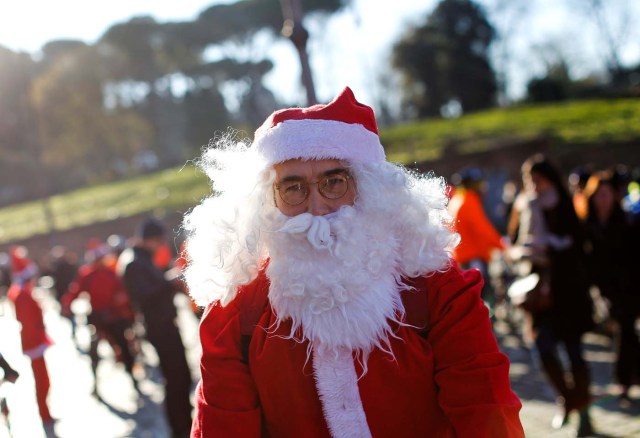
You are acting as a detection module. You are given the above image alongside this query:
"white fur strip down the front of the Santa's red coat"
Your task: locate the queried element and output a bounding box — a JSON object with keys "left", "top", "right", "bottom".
{"left": 313, "top": 348, "right": 371, "bottom": 438}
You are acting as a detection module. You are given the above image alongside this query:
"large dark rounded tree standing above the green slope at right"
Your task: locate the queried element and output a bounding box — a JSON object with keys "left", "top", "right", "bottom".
{"left": 393, "top": 0, "right": 496, "bottom": 117}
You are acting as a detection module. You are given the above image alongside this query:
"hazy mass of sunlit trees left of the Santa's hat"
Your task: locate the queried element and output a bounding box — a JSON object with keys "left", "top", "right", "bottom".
{"left": 0, "top": 0, "right": 348, "bottom": 204}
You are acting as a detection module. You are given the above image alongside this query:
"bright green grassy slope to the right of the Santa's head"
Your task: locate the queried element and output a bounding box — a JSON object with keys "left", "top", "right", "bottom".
{"left": 380, "top": 99, "right": 640, "bottom": 163}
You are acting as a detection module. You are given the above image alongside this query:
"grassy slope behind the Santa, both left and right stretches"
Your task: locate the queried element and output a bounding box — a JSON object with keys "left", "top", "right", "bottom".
{"left": 0, "top": 99, "right": 640, "bottom": 243}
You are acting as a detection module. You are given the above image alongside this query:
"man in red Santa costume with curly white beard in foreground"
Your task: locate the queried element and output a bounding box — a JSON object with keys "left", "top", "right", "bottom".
{"left": 184, "top": 88, "right": 524, "bottom": 437}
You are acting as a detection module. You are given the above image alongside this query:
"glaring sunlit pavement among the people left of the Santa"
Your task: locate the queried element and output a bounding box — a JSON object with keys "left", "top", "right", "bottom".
{"left": 0, "top": 293, "right": 200, "bottom": 438}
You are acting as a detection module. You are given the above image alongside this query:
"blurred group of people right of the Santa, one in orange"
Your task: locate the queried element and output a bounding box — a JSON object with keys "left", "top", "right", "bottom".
{"left": 449, "top": 154, "right": 640, "bottom": 436}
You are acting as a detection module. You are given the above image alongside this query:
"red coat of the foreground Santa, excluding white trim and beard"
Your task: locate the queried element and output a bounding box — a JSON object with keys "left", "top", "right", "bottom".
{"left": 192, "top": 267, "right": 524, "bottom": 437}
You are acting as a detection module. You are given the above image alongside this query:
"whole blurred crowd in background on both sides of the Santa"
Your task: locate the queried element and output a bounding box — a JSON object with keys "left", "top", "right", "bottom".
{"left": 0, "top": 151, "right": 640, "bottom": 437}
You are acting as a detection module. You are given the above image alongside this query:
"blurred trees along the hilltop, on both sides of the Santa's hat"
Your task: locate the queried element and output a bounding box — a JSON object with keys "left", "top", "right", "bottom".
{"left": 0, "top": 0, "right": 640, "bottom": 209}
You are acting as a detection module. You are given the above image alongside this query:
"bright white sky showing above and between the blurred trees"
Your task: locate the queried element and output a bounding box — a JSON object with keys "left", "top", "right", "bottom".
{"left": 0, "top": 0, "right": 640, "bottom": 108}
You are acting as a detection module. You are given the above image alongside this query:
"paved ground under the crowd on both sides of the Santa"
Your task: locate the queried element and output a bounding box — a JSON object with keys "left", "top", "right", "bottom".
{"left": 0, "top": 293, "right": 640, "bottom": 438}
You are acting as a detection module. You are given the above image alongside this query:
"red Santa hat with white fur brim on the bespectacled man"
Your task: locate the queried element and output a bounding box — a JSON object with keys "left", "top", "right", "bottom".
{"left": 253, "top": 87, "right": 385, "bottom": 164}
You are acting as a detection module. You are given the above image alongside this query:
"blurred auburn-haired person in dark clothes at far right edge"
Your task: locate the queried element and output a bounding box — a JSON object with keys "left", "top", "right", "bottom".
{"left": 585, "top": 171, "right": 640, "bottom": 404}
